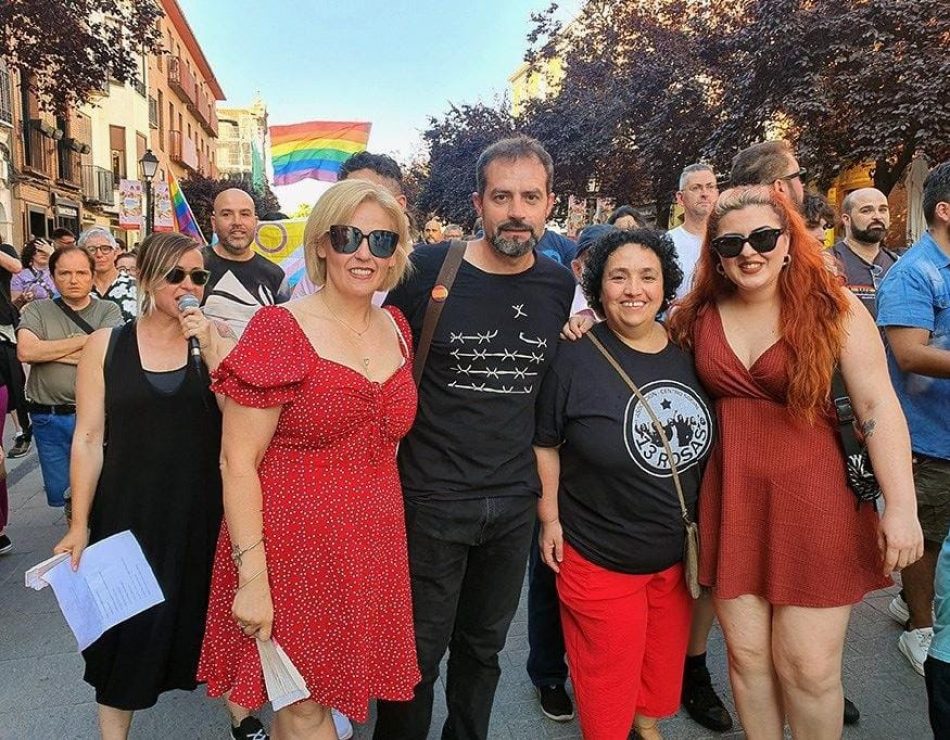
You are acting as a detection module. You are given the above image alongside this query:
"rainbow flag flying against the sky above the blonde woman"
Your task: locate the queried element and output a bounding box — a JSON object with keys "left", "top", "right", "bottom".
{"left": 270, "top": 121, "right": 373, "bottom": 185}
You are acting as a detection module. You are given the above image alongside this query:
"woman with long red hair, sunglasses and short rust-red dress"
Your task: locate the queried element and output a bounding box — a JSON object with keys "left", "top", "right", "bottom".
{"left": 670, "top": 186, "right": 922, "bottom": 740}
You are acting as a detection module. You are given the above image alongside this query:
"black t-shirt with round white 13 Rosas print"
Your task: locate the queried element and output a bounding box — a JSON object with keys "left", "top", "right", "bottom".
{"left": 535, "top": 323, "right": 715, "bottom": 574}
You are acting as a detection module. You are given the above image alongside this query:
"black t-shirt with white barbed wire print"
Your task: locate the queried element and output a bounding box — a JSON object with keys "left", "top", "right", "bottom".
{"left": 386, "top": 243, "right": 574, "bottom": 500}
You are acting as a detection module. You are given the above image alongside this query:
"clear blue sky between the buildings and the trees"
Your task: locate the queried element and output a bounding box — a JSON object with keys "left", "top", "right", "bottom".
{"left": 179, "top": 0, "right": 581, "bottom": 209}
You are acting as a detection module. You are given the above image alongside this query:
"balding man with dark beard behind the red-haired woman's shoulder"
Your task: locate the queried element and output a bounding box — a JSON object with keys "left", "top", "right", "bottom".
{"left": 831, "top": 188, "right": 897, "bottom": 317}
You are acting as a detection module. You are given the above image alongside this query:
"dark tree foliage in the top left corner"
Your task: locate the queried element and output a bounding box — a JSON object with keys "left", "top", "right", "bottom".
{"left": 0, "top": 0, "right": 162, "bottom": 115}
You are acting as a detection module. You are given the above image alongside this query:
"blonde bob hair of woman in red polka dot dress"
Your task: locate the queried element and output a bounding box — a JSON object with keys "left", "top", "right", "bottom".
{"left": 303, "top": 180, "right": 412, "bottom": 291}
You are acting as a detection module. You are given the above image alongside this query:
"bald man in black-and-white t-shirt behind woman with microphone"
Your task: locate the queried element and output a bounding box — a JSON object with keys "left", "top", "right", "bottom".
{"left": 202, "top": 188, "right": 290, "bottom": 336}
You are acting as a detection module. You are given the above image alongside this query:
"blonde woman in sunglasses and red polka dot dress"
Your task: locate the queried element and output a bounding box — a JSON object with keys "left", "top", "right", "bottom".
{"left": 198, "top": 180, "right": 419, "bottom": 739}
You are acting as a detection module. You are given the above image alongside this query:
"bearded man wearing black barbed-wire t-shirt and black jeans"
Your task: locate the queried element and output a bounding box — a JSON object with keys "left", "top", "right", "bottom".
{"left": 374, "top": 137, "right": 574, "bottom": 740}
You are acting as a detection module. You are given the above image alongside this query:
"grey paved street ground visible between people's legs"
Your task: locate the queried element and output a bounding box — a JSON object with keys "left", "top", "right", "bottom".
{"left": 0, "top": 440, "right": 931, "bottom": 740}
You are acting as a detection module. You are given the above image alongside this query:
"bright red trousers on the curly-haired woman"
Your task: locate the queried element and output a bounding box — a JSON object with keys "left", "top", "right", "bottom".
{"left": 557, "top": 542, "right": 692, "bottom": 740}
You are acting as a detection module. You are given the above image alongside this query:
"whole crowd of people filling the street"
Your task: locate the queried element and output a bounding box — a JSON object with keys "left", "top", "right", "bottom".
{"left": 0, "top": 136, "right": 950, "bottom": 740}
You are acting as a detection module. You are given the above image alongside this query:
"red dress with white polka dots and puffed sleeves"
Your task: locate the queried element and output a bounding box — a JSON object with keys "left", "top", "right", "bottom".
{"left": 198, "top": 306, "right": 419, "bottom": 722}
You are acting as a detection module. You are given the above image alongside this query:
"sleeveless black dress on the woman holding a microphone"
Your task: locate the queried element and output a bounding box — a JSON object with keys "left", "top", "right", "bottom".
{"left": 83, "top": 322, "right": 222, "bottom": 710}
